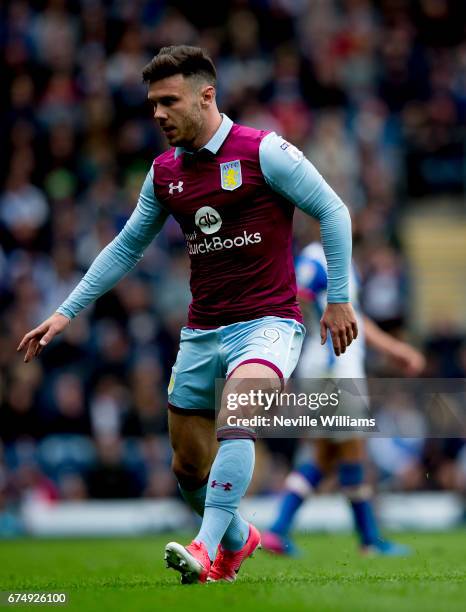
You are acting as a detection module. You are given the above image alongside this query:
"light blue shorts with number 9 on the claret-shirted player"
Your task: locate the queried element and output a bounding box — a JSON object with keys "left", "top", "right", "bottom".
{"left": 168, "top": 317, "right": 306, "bottom": 410}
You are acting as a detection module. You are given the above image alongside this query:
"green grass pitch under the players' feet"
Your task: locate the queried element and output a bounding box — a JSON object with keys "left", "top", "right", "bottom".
{"left": 0, "top": 531, "right": 466, "bottom": 612}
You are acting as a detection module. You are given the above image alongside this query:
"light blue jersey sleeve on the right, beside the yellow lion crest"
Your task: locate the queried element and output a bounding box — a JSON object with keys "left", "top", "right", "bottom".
{"left": 259, "top": 132, "right": 351, "bottom": 303}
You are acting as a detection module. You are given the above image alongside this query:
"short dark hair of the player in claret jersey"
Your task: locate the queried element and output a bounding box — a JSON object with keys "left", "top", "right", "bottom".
{"left": 142, "top": 45, "right": 217, "bottom": 85}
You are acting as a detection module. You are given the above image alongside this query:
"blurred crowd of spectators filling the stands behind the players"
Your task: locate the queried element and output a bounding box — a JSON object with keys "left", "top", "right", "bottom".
{"left": 0, "top": 0, "right": 466, "bottom": 529}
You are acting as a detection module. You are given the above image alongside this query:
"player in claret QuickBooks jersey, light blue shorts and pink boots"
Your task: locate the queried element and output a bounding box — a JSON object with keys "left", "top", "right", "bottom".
{"left": 14, "top": 46, "right": 357, "bottom": 582}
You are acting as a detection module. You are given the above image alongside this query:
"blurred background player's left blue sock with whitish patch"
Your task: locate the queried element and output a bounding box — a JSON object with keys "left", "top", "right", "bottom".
{"left": 270, "top": 463, "right": 322, "bottom": 537}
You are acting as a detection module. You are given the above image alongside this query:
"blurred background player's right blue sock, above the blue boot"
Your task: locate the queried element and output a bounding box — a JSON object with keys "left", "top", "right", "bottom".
{"left": 339, "top": 463, "right": 380, "bottom": 546}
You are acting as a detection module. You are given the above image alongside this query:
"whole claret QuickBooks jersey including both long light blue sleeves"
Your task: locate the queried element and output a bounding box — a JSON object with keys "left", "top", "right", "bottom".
{"left": 58, "top": 115, "right": 351, "bottom": 329}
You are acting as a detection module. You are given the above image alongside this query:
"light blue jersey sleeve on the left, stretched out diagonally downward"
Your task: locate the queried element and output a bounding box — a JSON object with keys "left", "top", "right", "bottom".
{"left": 57, "top": 169, "right": 169, "bottom": 319}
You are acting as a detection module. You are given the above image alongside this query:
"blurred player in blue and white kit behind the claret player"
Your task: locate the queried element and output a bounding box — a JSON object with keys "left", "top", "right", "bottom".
{"left": 262, "top": 242, "right": 425, "bottom": 556}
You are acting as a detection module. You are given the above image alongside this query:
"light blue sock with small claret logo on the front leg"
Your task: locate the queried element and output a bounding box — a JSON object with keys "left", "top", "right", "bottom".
{"left": 194, "top": 439, "right": 254, "bottom": 559}
